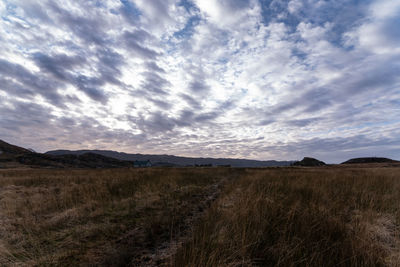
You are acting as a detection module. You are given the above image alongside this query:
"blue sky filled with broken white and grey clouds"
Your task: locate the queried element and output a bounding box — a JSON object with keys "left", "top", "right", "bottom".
{"left": 0, "top": 0, "right": 400, "bottom": 163}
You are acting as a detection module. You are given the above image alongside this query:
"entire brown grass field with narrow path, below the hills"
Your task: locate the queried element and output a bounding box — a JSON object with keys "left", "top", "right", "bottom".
{"left": 0, "top": 167, "right": 400, "bottom": 266}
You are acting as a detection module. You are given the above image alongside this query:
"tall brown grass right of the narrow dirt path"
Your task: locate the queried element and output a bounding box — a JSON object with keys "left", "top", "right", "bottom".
{"left": 174, "top": 168, "right": 400, "bottom": 266}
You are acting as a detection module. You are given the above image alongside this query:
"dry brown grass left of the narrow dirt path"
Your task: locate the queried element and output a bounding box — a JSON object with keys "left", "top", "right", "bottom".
{"left": 0, "top": 169, "right": 236, "bottom": 266}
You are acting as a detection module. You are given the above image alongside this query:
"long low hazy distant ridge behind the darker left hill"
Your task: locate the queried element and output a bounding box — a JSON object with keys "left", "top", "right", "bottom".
{"left": 45, "top": 150, "right": 293, "bottom": 167}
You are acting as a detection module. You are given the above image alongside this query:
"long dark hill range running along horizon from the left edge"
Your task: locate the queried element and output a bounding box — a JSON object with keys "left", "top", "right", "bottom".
{"left": 0, "top": 140, "right": 292, "bottom": 168}
